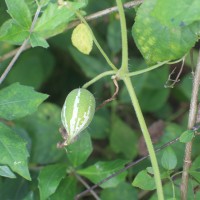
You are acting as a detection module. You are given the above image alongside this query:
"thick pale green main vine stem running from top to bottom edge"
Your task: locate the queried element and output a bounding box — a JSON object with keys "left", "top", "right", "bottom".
{"left": 116, "top": 0, "right": 164, "bottom": 200}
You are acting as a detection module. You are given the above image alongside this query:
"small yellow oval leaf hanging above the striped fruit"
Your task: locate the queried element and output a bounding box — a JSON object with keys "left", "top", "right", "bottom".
{"left": 71, "top": 24, "right": 93, "bottom": 55}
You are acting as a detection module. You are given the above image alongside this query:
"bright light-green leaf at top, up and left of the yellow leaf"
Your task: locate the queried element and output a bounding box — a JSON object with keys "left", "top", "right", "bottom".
{"left": 34, "top": 2, "right": 83, "bottom": 38}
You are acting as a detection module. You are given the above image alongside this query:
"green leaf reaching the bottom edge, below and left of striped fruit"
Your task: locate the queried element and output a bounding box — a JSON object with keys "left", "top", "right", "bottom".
{"left": 38, "top": 164, "right": 66, "bottom": 200}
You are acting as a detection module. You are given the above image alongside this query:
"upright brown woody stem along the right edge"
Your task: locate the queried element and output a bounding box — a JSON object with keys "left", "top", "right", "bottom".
{"left": 181, "top": 50, "right": 200, "bottom": 200}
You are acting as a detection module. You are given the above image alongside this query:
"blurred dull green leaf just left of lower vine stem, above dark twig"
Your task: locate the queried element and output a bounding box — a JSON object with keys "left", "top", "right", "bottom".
{"left": 110, "top": 118, "right": 138, "bottom": 159}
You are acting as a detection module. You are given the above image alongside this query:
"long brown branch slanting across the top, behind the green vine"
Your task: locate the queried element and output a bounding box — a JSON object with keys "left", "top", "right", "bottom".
{"left": 0, "top": 0, "right": 143, "bottom": 63}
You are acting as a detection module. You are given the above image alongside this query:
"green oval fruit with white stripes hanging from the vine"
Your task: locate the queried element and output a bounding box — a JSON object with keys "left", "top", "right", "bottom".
{"left": 61, "top": 88, "right": 95, "bottom": 145}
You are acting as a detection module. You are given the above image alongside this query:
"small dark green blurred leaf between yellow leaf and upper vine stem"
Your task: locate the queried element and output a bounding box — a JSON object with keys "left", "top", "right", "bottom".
{"left": 107, "top": 20, "right": 122, "bottom": 54}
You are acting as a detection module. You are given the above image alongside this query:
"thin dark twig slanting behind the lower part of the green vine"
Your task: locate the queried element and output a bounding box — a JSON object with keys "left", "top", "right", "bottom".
{"left": 75, "top": 137, "right": 179, "bottom": 200}
